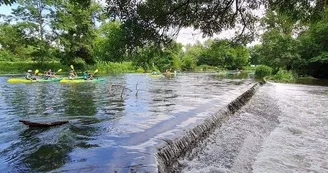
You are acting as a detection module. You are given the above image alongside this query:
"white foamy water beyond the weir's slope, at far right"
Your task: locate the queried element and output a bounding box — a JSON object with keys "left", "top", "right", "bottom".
{"left": 253, "top": 84, "right": 328, "bottom": 173}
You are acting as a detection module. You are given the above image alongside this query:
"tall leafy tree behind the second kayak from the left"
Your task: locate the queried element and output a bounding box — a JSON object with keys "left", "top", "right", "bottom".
{"left": 52, "top": 1, "right": 102, "bottom": 64}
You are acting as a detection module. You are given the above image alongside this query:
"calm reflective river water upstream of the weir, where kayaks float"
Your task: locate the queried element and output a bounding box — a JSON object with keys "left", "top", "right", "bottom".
{"left": 0, "top": 74, "right": 254, "bottom": 172}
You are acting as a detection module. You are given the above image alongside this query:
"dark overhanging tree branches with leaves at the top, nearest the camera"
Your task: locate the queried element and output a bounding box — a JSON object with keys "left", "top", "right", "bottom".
{"left": 107, "top": 0, "right": 327, "bottom": 47}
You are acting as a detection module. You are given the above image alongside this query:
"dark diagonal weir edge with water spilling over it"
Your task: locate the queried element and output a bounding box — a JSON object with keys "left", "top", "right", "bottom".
{"left": 156, "top": 82, "right": 265, "bottom": 173}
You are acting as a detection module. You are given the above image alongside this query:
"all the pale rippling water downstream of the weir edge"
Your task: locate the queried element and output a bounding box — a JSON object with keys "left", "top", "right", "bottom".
{"left": 177, "top": 83, "right": 328, "bottom": 173}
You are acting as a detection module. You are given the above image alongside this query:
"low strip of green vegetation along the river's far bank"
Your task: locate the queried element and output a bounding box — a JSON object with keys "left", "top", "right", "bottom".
{"left": 0, "top": 61, "right": 328, "bottom": 85}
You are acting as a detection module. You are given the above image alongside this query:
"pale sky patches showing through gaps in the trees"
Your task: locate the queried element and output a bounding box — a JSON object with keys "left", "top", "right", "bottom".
{"left": 0, "top": 3, "right": 263, "bottom": 45}
